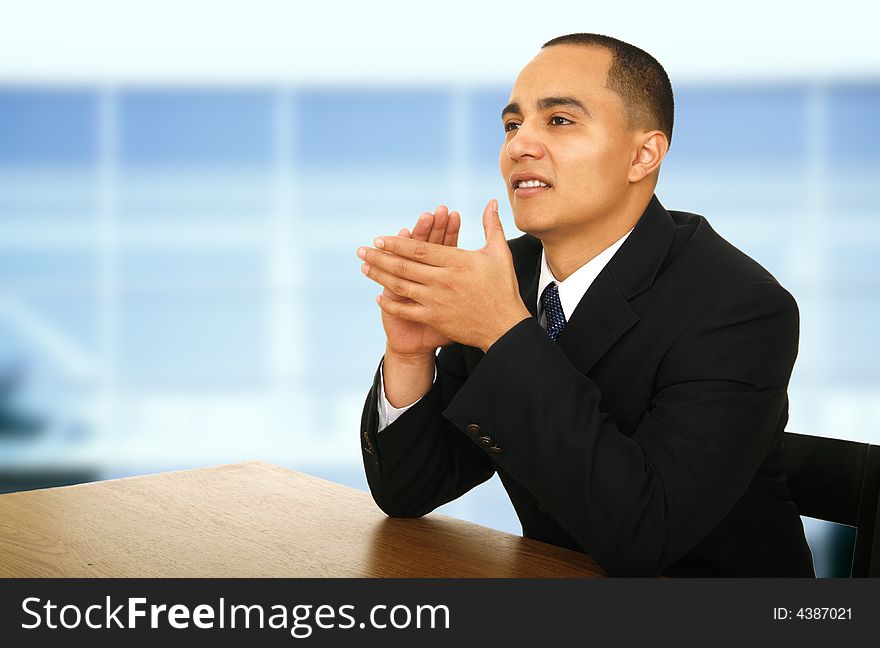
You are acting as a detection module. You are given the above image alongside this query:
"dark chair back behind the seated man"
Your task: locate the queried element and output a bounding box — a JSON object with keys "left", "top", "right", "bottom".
{"left": 783, "top": 432, "right": 880, "bottom": 577}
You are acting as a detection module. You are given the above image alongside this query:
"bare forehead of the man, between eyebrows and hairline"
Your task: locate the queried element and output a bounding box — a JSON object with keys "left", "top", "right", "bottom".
{"left": 510, "top": 45, "right": 616, "bottom": 110}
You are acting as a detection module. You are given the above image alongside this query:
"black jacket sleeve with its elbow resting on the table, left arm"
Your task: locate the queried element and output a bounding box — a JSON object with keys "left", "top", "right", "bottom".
{"left": 361, "top": 344, "right": 495, "bottom": 517}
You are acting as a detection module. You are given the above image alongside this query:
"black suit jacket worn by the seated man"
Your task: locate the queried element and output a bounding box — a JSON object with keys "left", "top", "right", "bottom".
{"left": 361, "top": 197, "right": 813, "bottom": 576}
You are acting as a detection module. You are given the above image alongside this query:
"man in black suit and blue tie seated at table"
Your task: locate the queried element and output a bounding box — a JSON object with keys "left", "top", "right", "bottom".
{"left": 358, "top": 34, "right": 813, "bottom": 576}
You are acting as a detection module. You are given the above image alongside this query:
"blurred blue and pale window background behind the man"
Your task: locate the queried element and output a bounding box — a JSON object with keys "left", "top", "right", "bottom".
{"left": 0, "top": 82, "right": 880, "bottom": 575}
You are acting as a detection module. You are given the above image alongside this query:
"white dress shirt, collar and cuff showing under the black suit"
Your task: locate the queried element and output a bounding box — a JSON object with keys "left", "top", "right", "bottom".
{"left": 378, "top": 230, "right": 632, "bottom": 432}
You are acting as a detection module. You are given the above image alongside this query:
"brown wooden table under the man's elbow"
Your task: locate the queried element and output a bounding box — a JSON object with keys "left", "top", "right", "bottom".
{"left": 0, "top": 462, "right": 603, "bottom": 578}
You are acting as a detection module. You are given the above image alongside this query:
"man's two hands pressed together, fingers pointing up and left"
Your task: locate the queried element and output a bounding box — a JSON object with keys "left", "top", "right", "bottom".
{"left": 357, "top": 200, "right": 530, "bottom": 356}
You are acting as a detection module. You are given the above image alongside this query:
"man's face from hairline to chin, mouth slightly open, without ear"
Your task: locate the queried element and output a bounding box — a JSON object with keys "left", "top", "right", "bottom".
{"left": 500, "top": 45, "right": 638, "bottom": 238}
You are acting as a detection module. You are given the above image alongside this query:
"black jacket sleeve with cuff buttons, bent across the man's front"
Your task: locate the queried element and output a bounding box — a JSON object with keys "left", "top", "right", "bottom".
{"left": 444, "top": 282, "right": 798, "bottom": 576}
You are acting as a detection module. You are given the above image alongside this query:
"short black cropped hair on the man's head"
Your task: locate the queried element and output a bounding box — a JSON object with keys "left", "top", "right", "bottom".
{"left": 541, "top": 34, "right": 675, "bottom": 143}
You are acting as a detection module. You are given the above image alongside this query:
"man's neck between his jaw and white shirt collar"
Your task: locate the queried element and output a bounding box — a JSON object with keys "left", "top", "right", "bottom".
{"left": 541, "top": 193, "right": 653, "bottom": 281}
